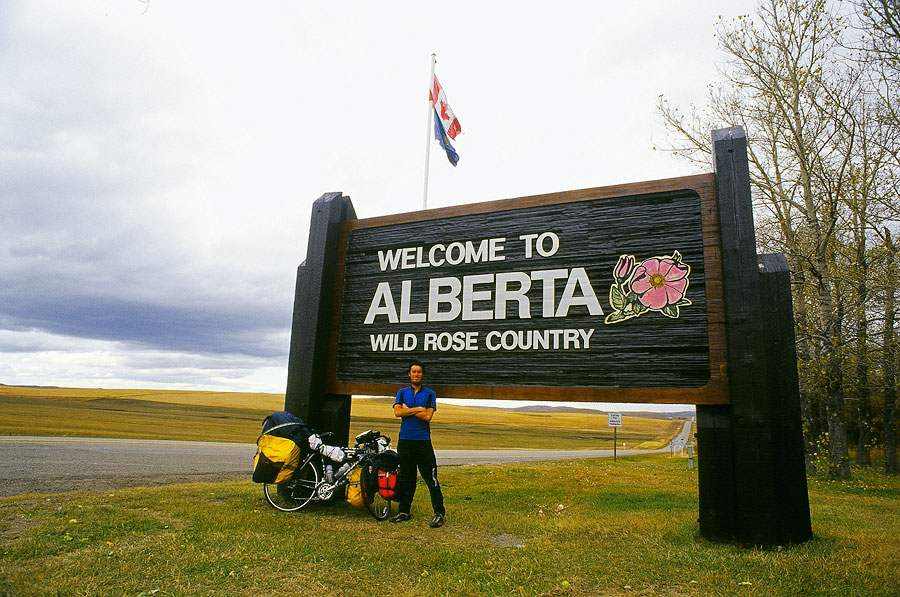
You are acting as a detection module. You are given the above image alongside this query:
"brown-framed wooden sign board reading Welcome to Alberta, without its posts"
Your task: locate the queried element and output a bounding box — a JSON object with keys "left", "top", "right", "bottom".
{"left": 327, "top": 175, "right": 728, "bottom": 404}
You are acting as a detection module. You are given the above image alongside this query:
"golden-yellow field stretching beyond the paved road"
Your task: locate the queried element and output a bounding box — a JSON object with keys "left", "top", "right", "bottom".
{"left": 0, "top": 386, "right": 681, "bottom": 449}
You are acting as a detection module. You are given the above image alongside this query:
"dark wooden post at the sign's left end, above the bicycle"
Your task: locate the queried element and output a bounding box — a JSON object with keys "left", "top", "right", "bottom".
{"left": 284, "top": 193, "right": 356, "bottom": 446}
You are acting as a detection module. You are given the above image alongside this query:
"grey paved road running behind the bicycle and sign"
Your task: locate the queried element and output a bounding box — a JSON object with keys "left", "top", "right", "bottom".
{"left": 0, "top": 422, "right": 691, "bottom": 497}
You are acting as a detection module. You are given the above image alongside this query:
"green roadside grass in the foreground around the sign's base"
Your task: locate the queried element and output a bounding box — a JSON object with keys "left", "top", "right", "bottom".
{"left": 0, "top": 455, "right": 900, "bottom": 596}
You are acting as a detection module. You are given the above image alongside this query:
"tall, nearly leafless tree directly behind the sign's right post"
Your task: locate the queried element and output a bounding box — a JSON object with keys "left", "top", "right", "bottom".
{"left": 659, "top": 0, "right": 896, "bottom": 478}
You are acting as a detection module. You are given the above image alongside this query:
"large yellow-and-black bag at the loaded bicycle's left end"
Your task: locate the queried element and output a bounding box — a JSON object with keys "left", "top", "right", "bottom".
{"left": 253, "top": 410, "right": 311, "bottom": 483}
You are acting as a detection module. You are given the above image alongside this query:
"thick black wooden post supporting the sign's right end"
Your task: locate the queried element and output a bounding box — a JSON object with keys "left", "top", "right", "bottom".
{"left": 697, "top": 127, "right": 812, "bottom": 546}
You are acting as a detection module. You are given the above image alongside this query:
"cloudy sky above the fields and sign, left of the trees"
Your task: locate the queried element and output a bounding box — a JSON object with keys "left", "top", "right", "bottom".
{"left": 0, "top": 0, "right": 754, "bottom": 410}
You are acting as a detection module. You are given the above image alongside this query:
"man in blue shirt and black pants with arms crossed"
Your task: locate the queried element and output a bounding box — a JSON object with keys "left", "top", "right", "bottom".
{"left": 391, "top": 361, "right": 445, "bottom": 528}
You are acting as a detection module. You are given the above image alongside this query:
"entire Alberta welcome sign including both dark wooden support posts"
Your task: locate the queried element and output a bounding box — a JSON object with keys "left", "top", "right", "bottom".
{"left": 285, "top": 128, "right": 812, "bottom": 545}
